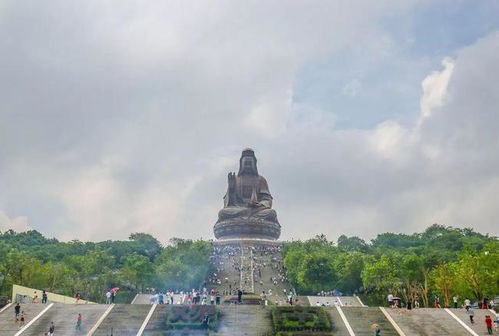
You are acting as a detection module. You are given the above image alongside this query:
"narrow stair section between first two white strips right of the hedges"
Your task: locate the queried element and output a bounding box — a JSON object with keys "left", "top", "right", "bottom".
{"left": 341, "top": 306, "right": 398, "bottom": 336}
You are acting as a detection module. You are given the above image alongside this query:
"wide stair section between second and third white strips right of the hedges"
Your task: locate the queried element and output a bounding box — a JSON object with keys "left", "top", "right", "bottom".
{"left": 386, "top": 308, "right": 469, "bottom": 336}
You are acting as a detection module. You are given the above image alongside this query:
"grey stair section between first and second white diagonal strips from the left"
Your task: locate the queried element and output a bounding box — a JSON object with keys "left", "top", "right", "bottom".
{"left": 23, "top": 303, "right": 108, "bottom": 336}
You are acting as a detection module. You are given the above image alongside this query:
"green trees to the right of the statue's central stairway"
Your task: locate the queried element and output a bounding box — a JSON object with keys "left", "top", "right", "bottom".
{"left": 283, "top": 224, "right": 499, "bottom": 306}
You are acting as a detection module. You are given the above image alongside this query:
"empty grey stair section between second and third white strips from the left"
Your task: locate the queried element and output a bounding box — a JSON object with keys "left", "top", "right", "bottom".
{"left": 94, "top": 304, "right": 151, "bottom": 336}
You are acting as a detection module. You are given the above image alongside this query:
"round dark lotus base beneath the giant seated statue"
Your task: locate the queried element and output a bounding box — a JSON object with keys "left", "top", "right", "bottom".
{"left": 214, "top": 218, "right": 281, "bottom": 240}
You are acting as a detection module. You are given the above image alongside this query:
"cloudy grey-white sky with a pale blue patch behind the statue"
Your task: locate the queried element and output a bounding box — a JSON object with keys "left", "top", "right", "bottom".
{"left": 0, "top": 0, "right": 499, "bottom": 242}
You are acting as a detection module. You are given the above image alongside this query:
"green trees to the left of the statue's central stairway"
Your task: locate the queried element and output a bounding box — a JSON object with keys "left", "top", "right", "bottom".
{"left": 0, "top": 230, "right": 212, "bottom": 302}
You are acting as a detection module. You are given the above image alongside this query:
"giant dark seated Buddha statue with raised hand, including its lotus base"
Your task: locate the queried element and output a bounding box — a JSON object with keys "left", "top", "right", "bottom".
{"left": 214, "top": 148, "right": 281, "bottom": 240}
